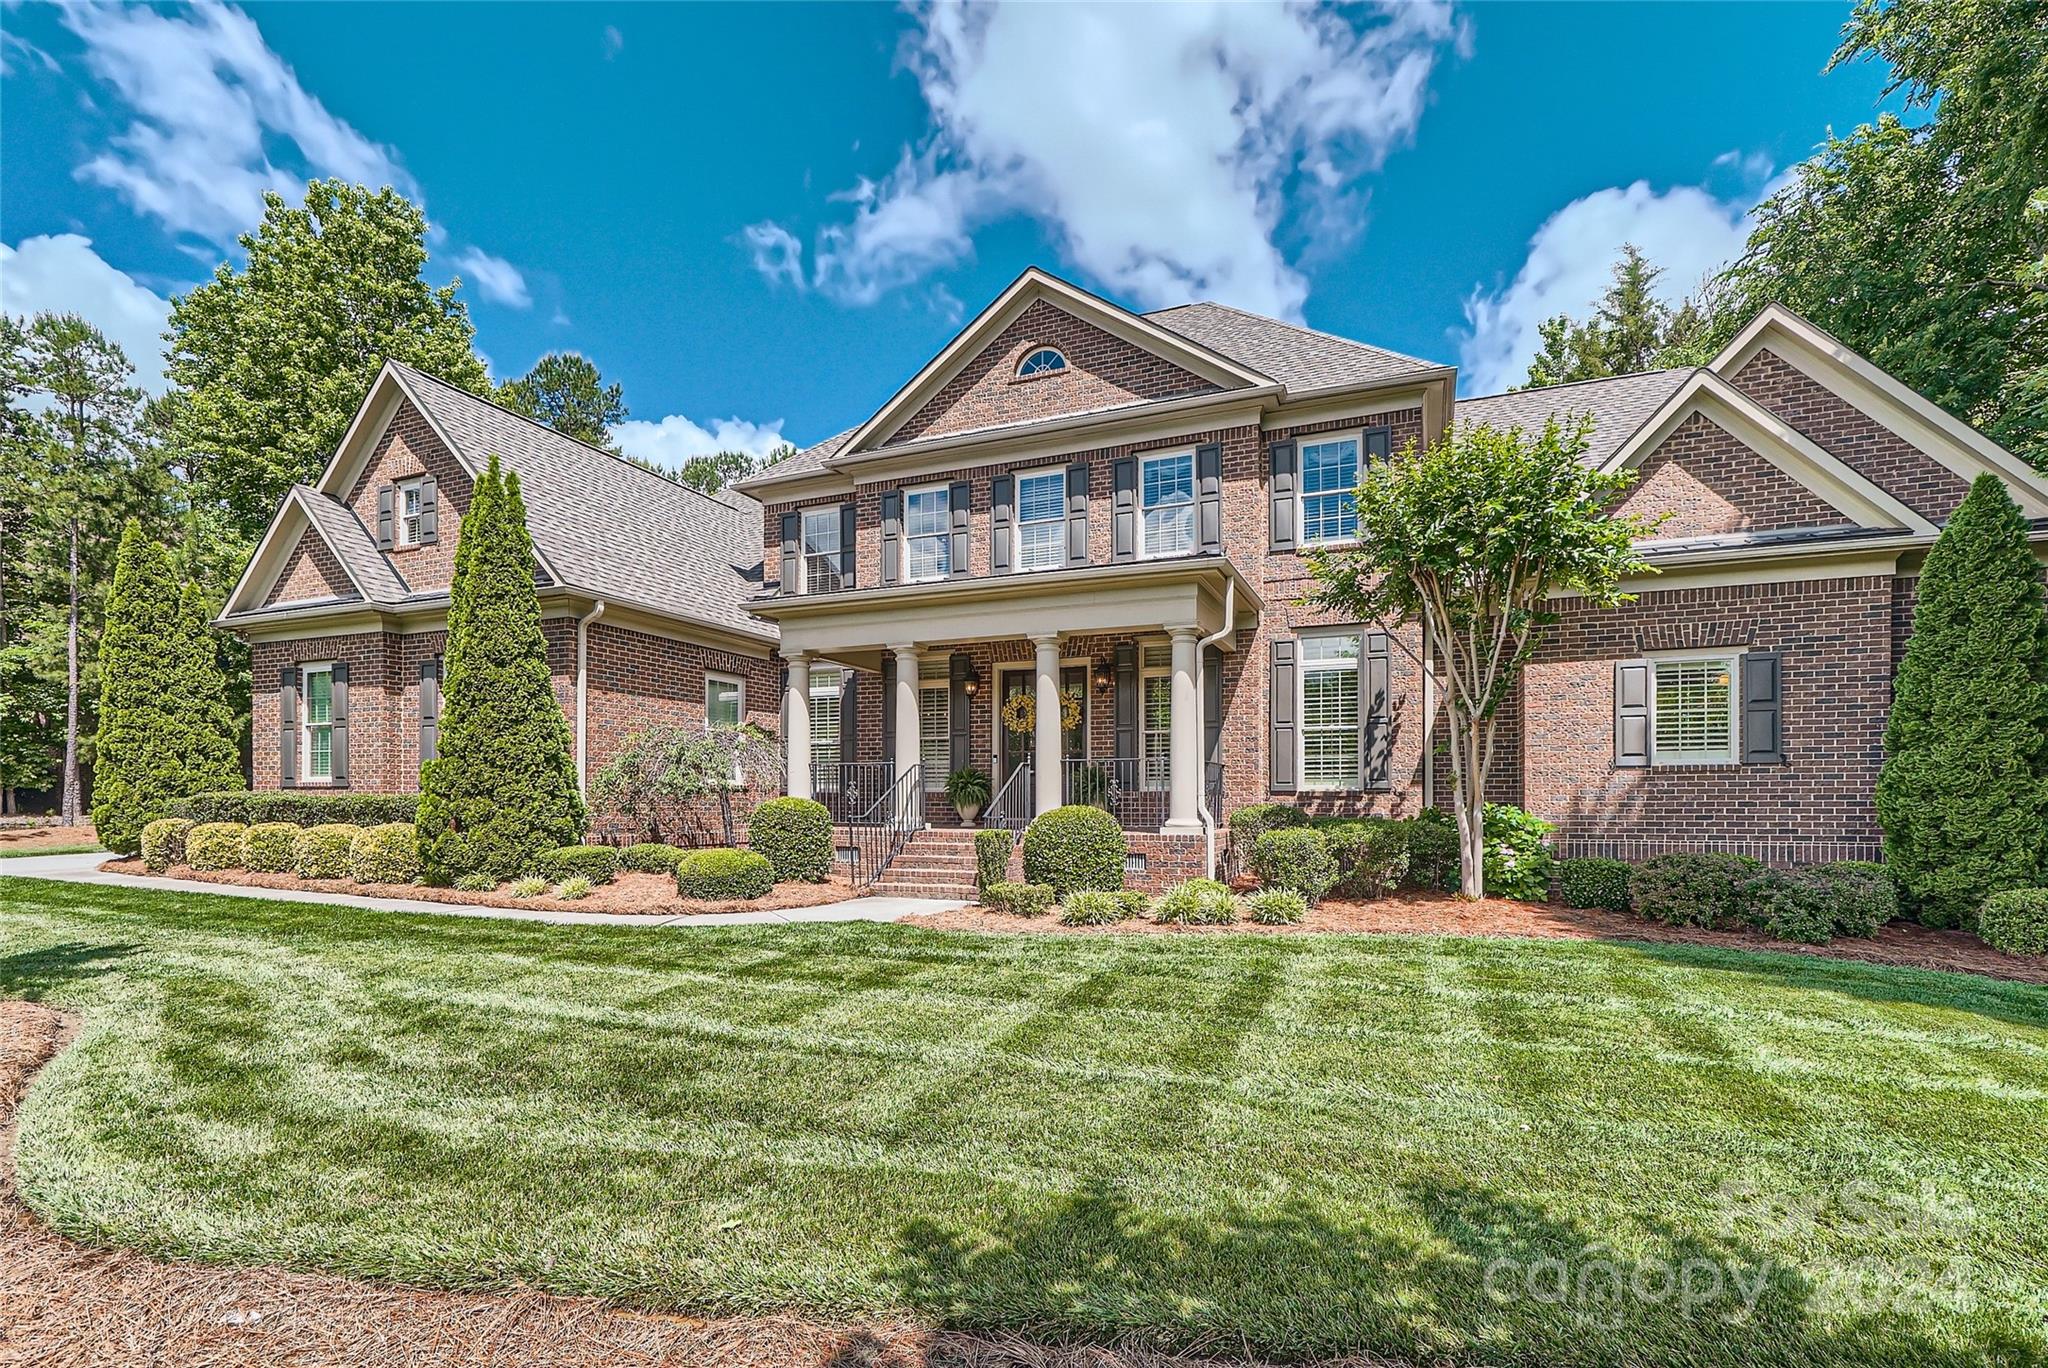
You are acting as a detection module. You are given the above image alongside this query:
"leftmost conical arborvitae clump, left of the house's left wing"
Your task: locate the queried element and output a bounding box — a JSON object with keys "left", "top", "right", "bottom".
{"left": 92, "top": 522, "right": 242, "bottom": 854}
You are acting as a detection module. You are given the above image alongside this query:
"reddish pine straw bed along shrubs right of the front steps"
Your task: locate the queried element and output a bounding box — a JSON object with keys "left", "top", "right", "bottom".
{"left": 921, "top": 893, "right": 2048, "bottom": 983}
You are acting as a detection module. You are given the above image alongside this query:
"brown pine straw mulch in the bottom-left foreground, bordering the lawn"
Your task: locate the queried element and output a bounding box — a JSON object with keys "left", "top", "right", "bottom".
{"left": 0, "top": 1001, "right": 1395, "bottom": 1368}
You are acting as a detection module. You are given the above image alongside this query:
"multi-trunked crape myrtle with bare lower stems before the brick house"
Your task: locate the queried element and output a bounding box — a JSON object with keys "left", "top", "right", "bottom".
{"left": 1307, "top": 418, "right": 1655, "bottom": 897}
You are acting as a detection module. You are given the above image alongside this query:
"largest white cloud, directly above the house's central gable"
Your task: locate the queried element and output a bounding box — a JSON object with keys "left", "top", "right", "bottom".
{"left": 748, "top": 2, "right": 1464, "bottom": 317}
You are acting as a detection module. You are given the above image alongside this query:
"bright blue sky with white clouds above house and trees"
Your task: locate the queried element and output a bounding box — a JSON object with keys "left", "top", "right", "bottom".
{"left": 0, "top": 2, "right": 1882, "bottom": 461}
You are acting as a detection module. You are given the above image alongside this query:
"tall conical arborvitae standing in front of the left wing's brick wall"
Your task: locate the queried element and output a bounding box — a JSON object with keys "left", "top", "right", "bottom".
{"left": 420, "top": 457, "right": 588, "bottom": 883}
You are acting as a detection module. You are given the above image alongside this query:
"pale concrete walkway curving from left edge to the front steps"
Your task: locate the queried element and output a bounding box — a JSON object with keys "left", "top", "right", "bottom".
{"left": 0, "top": 852, "right": 963, "bottom": 926}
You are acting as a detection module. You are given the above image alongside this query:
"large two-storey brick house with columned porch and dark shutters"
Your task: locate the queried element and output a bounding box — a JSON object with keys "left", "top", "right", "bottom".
{"left": 225, "top": 270, "right": 2048, "bottom": 887}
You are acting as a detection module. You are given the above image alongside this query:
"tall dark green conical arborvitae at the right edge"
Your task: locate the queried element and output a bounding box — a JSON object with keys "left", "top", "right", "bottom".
{"left": 1878, "top": 475, "right": 2048, "bottom": 926}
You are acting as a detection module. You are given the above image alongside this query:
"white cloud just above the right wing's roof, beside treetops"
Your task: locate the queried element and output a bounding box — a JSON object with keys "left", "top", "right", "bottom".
{"left": 1458, "top": 171, "right": 1782, "bottom": 395}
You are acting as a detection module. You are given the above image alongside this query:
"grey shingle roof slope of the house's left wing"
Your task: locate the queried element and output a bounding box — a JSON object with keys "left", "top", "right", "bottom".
{"left": 393, "top": 362, "right": 774, "bottom": 637}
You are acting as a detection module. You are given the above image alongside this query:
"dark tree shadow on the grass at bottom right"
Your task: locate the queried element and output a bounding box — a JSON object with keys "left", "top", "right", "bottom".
{"left": 895, "top": 1180, "right": 2044, "bottom": 1368}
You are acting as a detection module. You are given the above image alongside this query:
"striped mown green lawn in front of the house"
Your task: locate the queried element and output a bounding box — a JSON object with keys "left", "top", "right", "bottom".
{"left": 0, "top": 879, "right": 2048, "bottom": 1368}
